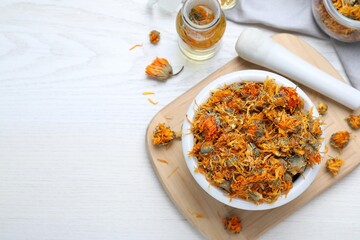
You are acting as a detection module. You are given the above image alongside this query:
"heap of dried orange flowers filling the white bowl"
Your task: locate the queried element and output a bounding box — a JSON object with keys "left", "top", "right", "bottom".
{"left": 189, "top": 78, "right": 323, "bottom": 204}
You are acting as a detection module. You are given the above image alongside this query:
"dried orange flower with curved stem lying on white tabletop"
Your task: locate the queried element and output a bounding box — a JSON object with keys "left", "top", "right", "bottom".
{"left": 145, "top": 57, "right": 184, "bottom": 80}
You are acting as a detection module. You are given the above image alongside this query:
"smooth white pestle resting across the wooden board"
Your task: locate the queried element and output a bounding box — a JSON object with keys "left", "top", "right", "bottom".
{"left": 235, "top": 28, "right": 360, "bottom": 110}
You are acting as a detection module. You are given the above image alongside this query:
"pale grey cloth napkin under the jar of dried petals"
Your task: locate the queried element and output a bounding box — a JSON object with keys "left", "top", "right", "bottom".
{"left": 225, "top": 0, "right": 360, "bottom": 89}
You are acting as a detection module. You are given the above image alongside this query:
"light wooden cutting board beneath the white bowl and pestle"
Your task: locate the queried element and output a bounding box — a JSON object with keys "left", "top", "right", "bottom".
{"left": 146, "top": 34, "right": 360, "bottom": 239}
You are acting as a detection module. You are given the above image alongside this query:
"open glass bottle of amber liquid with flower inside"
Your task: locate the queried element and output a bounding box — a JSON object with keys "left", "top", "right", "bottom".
{"left": 176, "top": 0, "right": 226, "bottom": 60}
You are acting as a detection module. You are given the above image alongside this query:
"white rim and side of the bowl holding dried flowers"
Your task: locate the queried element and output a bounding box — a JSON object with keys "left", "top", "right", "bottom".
{"left": 182, "top": 70, "right": 324, "bottom": 210}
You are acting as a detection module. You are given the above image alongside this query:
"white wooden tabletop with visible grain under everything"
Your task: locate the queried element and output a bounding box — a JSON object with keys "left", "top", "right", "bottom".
{"left": 0, "top": 0, "right": 360, "bottom": 240}
